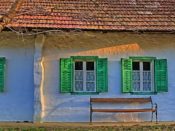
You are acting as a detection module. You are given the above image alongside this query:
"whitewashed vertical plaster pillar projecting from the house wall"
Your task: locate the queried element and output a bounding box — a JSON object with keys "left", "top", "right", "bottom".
{"left": 33, "top": 35, "right": 45, "bottom": 122}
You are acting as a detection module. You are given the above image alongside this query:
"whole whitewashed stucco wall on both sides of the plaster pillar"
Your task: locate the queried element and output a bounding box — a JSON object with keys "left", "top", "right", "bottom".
{"left": 0, "top": 32, "right": 175, "bottom": 122}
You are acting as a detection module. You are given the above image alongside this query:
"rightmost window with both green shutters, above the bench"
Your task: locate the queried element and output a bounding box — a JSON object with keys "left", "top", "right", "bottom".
{"left": 121, "top": 56, "right": 168, "bottom": 94}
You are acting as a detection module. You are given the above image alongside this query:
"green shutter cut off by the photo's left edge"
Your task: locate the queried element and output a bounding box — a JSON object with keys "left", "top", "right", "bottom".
{"left": 0, "top": 58, "right": 5, "bottom": 92}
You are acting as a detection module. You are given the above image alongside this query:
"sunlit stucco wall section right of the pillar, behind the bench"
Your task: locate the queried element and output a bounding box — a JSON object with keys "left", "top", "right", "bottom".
{"left": 42, "top": 32, "right": 175, "bottom": 122}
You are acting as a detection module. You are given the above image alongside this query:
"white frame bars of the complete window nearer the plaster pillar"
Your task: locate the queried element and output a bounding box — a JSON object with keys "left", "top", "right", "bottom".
{"left": 73, "top": 60, "right": 96, "bottom": 93}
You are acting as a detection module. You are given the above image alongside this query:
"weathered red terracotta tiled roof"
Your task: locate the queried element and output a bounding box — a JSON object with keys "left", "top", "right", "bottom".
{"left": 0, "top": 0, "right": 175, "bottom": 31}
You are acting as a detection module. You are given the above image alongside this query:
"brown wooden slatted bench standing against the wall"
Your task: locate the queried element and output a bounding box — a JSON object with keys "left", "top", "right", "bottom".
{"left": 90, "top": 97, "right": 157, "bottom": 122}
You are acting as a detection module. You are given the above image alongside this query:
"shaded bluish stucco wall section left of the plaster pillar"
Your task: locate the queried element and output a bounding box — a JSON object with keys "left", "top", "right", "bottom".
{"left": 0, "top": 33, "right": 34, "bottom": 121}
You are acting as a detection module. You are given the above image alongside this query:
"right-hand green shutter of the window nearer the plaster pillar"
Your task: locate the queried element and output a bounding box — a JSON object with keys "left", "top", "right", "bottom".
{"left": 97, "top": 58, "right": 108, "bottom": 92}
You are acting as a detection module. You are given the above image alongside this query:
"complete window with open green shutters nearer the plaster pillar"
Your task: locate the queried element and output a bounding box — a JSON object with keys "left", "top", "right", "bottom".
{"left": 60, "top": 56, "right": 108, "bottom": 94}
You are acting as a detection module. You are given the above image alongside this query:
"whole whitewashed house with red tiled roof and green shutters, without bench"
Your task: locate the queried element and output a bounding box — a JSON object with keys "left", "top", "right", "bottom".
{"left": 0, "top": 0, "right": 175, "bottom": 122}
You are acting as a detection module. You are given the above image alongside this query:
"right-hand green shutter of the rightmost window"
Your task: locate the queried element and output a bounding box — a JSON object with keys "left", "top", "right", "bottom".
{"left": 155, "top": 59, "right": 168, "bottom": 92}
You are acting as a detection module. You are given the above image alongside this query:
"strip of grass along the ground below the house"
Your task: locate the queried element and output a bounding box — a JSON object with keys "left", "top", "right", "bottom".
{"left": 0, "top": 125, "right": 175, "bottom": 131}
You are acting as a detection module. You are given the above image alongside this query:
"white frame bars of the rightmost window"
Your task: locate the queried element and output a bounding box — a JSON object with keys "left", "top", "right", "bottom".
{"left": 132, "top": 60, "right": 154, "bottom": 93}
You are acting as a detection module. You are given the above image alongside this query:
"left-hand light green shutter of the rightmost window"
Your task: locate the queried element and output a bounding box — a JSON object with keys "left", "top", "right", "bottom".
{"left": 121, "top": 58, "right": 132, "bottom": 93}
